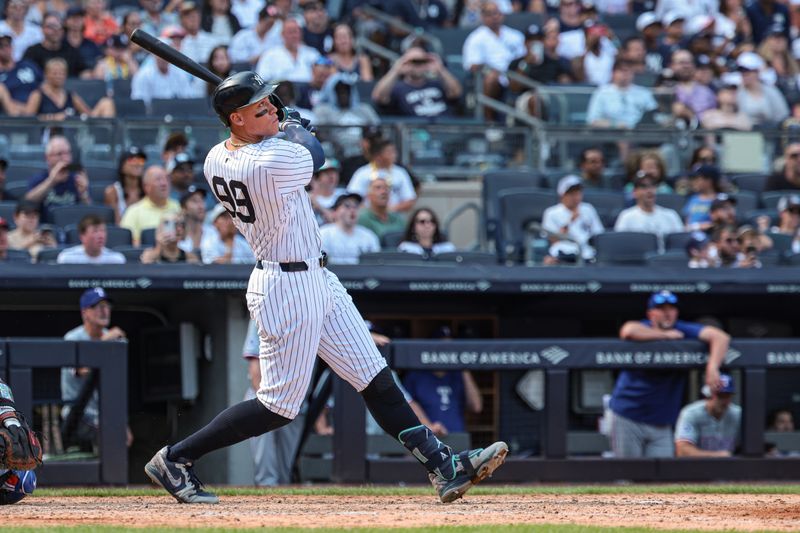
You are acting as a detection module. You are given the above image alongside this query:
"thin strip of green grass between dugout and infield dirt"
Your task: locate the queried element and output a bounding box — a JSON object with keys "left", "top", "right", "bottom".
{"left": 32, "top": 483, "right": 800, "bottom": 498}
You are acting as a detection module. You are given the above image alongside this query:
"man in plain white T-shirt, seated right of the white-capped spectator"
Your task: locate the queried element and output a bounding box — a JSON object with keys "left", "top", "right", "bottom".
{"left": 614, "top": 174, "right": 683, "bottom": 249}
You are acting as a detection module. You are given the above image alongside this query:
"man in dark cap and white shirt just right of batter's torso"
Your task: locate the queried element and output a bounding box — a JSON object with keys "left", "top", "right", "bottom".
{"left": 319, "top": 193, "right": 381, "bottom": 265}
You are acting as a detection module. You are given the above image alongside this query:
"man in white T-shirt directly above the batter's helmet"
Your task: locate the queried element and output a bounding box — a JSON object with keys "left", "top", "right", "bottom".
{"left": 256, "top": 19, "right": 319, "bottom": 83}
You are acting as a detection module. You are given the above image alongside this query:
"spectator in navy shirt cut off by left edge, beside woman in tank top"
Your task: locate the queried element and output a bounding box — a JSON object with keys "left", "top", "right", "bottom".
{"left": 0, "top": 31, "right": 42, "bottom": 116}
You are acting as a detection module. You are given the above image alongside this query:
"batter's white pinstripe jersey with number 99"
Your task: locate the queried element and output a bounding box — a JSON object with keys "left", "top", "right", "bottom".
{"left": 203, "top": 136, "right": 322, "bottom": 262}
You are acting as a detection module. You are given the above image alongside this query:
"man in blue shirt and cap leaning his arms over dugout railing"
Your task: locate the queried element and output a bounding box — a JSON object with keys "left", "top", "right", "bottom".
{"left": 610, "top": 291, "right": 730, "bottom": 458}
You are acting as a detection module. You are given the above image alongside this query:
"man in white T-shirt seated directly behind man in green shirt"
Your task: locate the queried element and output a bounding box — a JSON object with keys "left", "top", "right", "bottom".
{"left": 347, "top": 139, "right": 417, "bottom": 212}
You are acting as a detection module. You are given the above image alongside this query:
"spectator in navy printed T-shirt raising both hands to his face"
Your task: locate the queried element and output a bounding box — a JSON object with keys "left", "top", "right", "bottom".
{"left": 372, "top": 46, "right": 461, "bottom": 118}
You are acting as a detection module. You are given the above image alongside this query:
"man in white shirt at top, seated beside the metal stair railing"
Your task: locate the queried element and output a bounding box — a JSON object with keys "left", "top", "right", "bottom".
{"left": 461, "top": 0, "right": 524, "bottom": 120}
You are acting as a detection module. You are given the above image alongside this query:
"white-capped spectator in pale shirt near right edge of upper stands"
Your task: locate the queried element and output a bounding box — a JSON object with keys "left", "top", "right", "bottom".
{"left": 736, "top": 52, "right": 789, "bottom": 126}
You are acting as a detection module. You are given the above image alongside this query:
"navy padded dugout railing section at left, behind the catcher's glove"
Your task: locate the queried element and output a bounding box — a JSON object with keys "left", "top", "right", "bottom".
{"left": 0, "top": 337, "right": 128, "bottom": 485}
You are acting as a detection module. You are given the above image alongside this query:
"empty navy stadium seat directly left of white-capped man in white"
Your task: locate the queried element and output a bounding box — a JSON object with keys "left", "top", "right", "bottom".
{"left": 497, "top": 187, "right": 558, "bottom": 259}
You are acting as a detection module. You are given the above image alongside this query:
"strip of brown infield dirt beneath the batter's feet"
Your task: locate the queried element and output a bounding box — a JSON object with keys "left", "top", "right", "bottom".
{"left": 9, "top": 488, "right": 800, "bottom": 531}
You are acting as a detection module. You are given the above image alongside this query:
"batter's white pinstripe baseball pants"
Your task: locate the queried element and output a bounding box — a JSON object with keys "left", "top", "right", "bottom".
{"left": 247, "top": 259, "right": 386, "bottom": 419}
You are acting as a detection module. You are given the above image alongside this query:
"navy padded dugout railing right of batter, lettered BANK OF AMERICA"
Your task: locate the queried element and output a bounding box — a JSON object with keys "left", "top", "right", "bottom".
{"left": 332, "top": 338, "right": 800, "bottom": 483}
